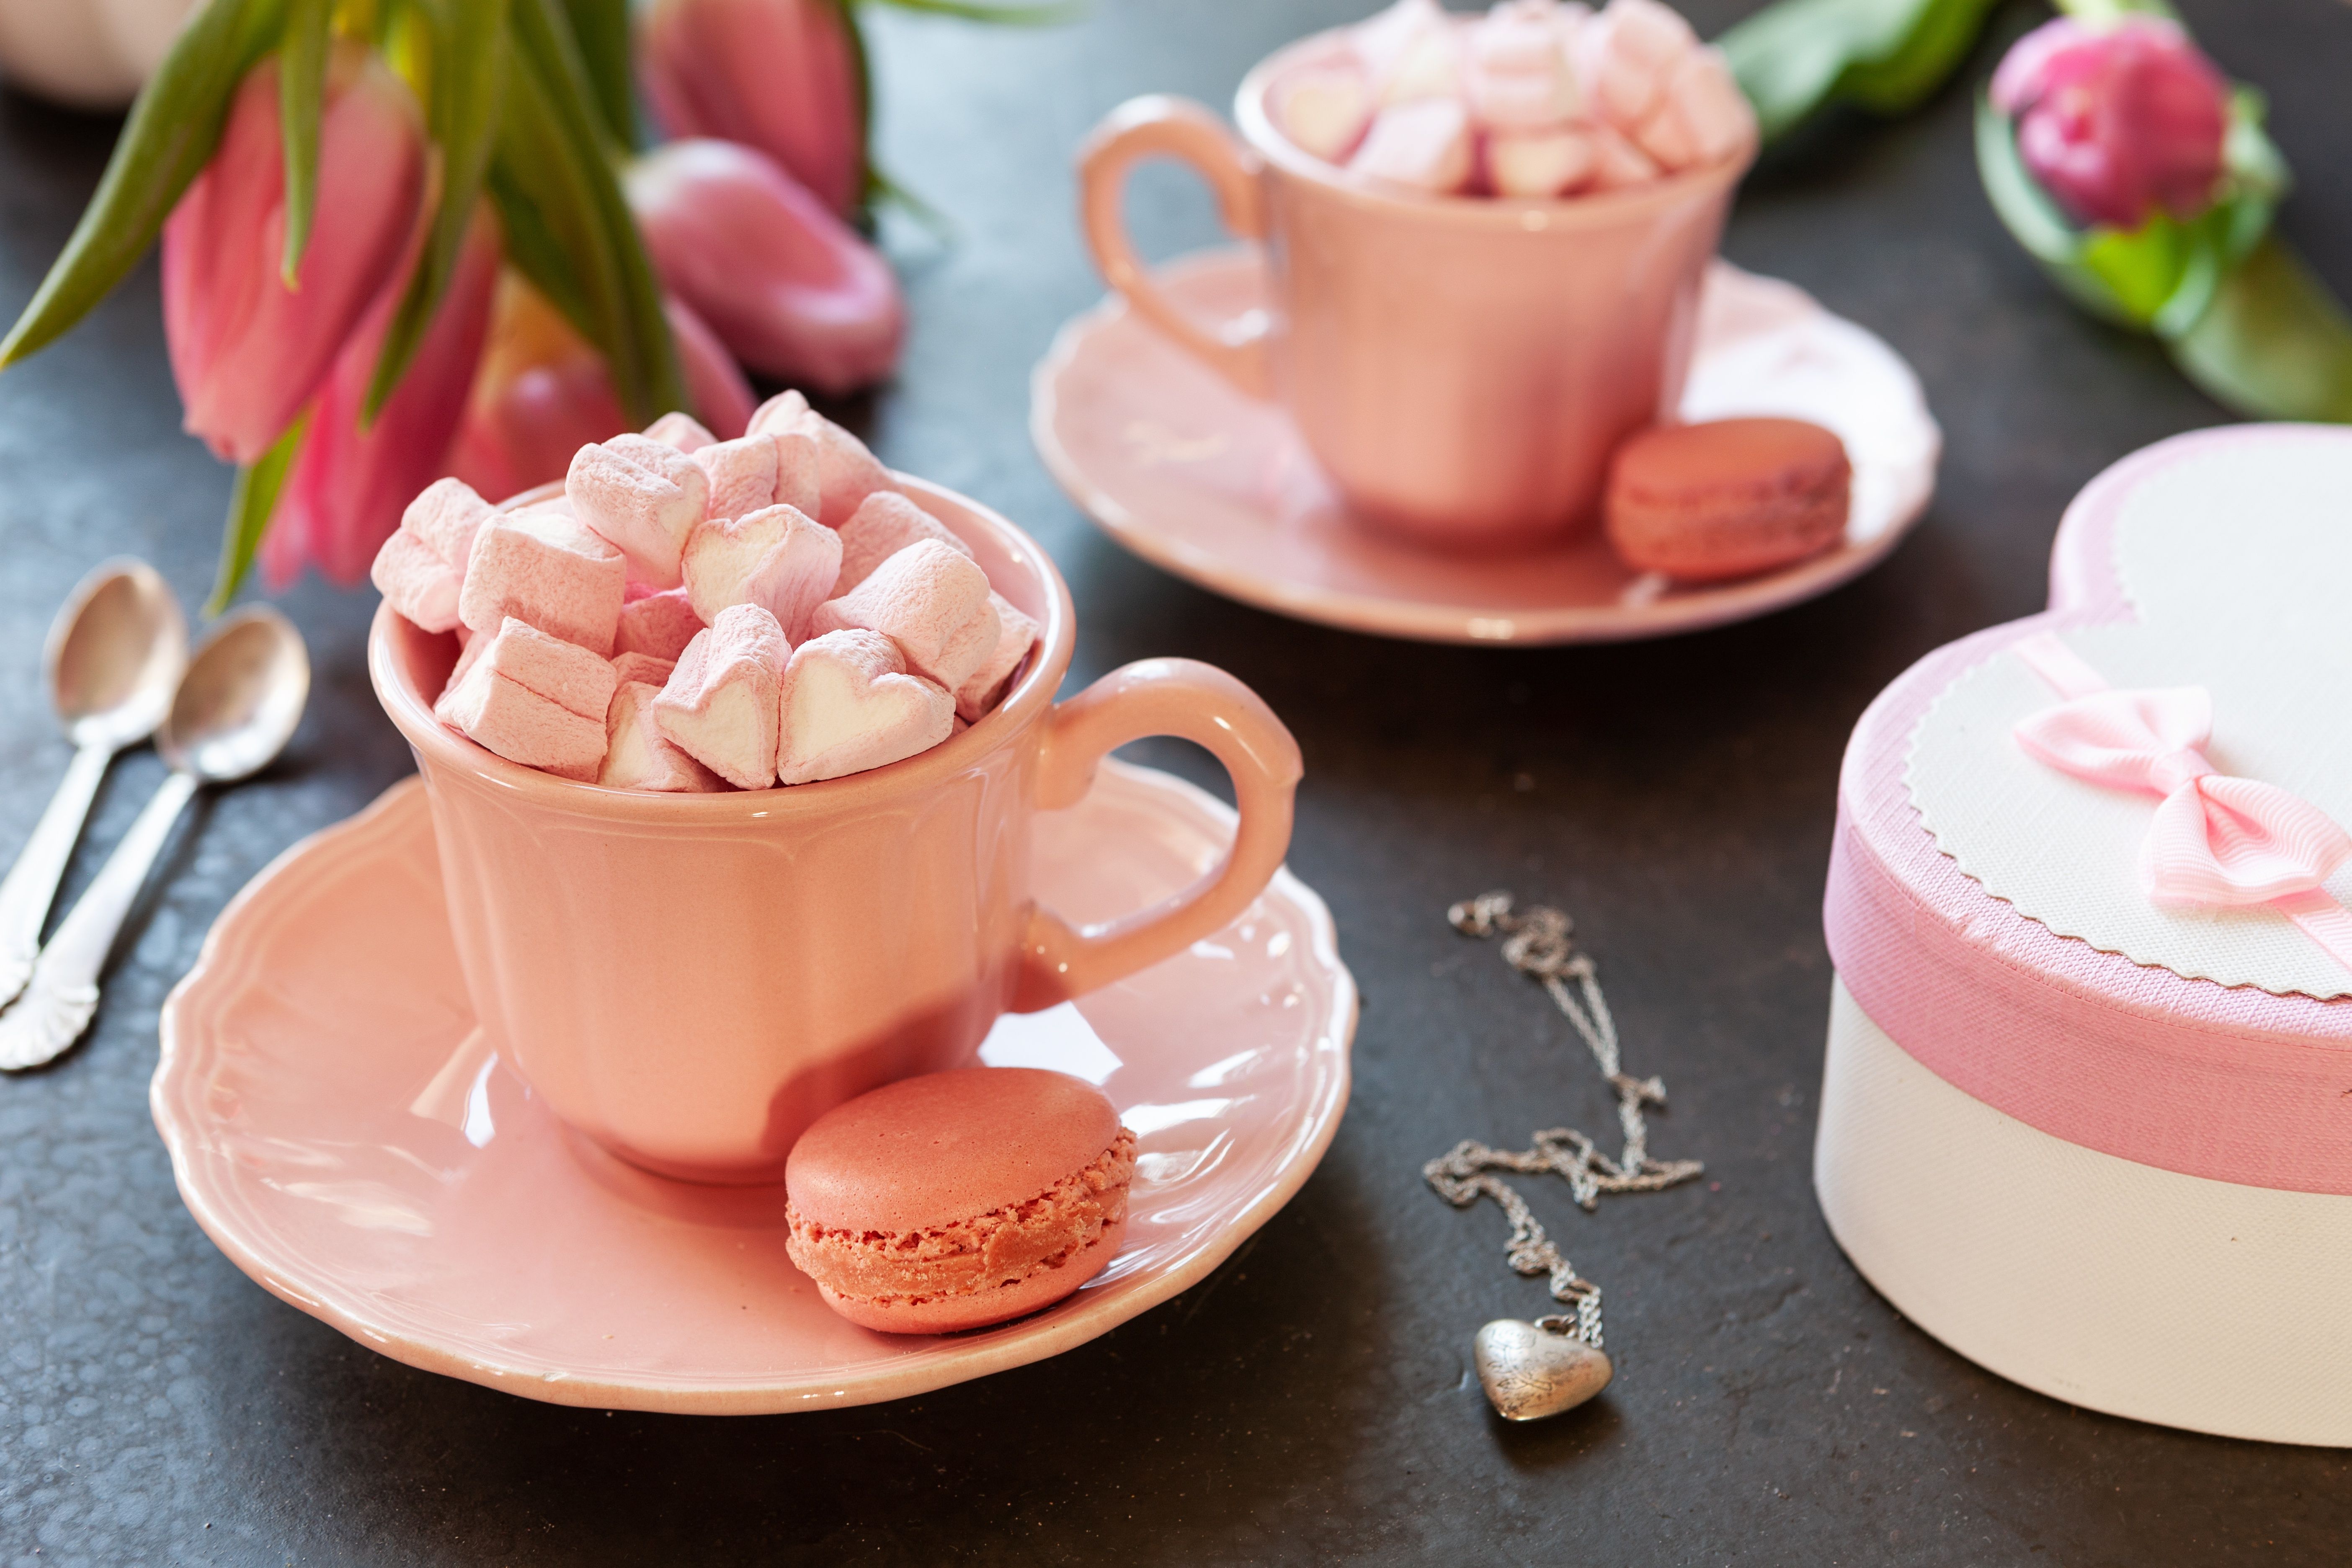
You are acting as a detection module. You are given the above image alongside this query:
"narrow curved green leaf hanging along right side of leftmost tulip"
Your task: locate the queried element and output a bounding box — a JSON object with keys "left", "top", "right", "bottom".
{"left": 360, "top": 0, "right": 511, "bottom": 430}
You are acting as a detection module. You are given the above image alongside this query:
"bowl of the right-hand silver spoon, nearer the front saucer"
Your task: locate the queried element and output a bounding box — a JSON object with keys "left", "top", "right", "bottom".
{"left": 155, "top": 604, "right": 310, "bottom": 783}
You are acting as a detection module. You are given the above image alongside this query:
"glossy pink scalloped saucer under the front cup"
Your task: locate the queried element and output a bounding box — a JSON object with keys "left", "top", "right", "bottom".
{"left": 150, "top": 762, "right": 1355, "bottom": 1415}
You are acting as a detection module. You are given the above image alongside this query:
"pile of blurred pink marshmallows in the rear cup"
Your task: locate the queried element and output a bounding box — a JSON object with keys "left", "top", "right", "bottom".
{"left": 1268, "top": 0, "right": 1755, "bottom": 198}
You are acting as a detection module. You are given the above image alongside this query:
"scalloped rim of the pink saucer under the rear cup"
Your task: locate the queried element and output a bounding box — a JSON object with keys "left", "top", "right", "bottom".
{"left": 1028, "top": 245, "right": 1943, "bottom": 647}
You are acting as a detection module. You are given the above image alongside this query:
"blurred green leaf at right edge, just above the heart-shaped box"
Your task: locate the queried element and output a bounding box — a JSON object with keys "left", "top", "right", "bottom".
{"left": 2166, "top": 235, "right": 2352, "bottom": 423}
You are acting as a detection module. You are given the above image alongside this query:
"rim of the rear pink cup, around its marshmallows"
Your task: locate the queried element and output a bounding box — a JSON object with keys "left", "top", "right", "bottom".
{"left": 1233, "top": 26, "right": 1757, "bottom": 233}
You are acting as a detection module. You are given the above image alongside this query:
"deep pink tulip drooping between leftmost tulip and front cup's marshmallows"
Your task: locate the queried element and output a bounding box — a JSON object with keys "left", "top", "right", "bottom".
{"left": 261, "top": 209, "right": 499, "bottom": 593}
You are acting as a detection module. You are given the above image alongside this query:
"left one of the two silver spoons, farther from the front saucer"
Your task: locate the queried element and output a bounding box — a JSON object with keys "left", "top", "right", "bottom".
{"left": 0, "top": 560, "right": 188, "bottom": 1006}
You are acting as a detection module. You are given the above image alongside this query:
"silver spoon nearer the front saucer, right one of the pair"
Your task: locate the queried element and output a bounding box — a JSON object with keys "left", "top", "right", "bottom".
{"left": 0, "top": 604, "right": 310, "bottom": 1072}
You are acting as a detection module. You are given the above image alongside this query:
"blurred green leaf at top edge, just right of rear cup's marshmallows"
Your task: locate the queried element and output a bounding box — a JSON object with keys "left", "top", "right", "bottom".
{"left": 1715, "top": 0, "right": 1994, "bottom": 141}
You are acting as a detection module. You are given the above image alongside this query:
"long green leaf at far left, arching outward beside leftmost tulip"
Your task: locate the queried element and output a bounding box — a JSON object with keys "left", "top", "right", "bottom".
{"left": 0, "top": 0, "right": 287, "bottom": 367}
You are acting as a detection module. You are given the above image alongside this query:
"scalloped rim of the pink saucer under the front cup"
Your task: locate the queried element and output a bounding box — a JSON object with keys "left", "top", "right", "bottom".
{"left": 148, "top": 757, "right": 1362, "bottom": 1415}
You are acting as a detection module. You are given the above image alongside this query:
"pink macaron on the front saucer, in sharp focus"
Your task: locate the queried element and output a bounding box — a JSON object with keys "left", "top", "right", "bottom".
{"left": 783, "top": 1067, "right": 1136, "bottom": 1333}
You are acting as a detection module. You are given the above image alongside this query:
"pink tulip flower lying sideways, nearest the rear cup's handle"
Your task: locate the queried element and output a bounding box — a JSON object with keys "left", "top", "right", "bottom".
{"left": 623, "top": 141, "right": 905, "bottom": 392}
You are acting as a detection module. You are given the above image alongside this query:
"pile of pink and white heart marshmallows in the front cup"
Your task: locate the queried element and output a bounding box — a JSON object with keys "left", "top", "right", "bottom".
{"left": 374, "top": 392, "right": 1037, "bottom": 790}
